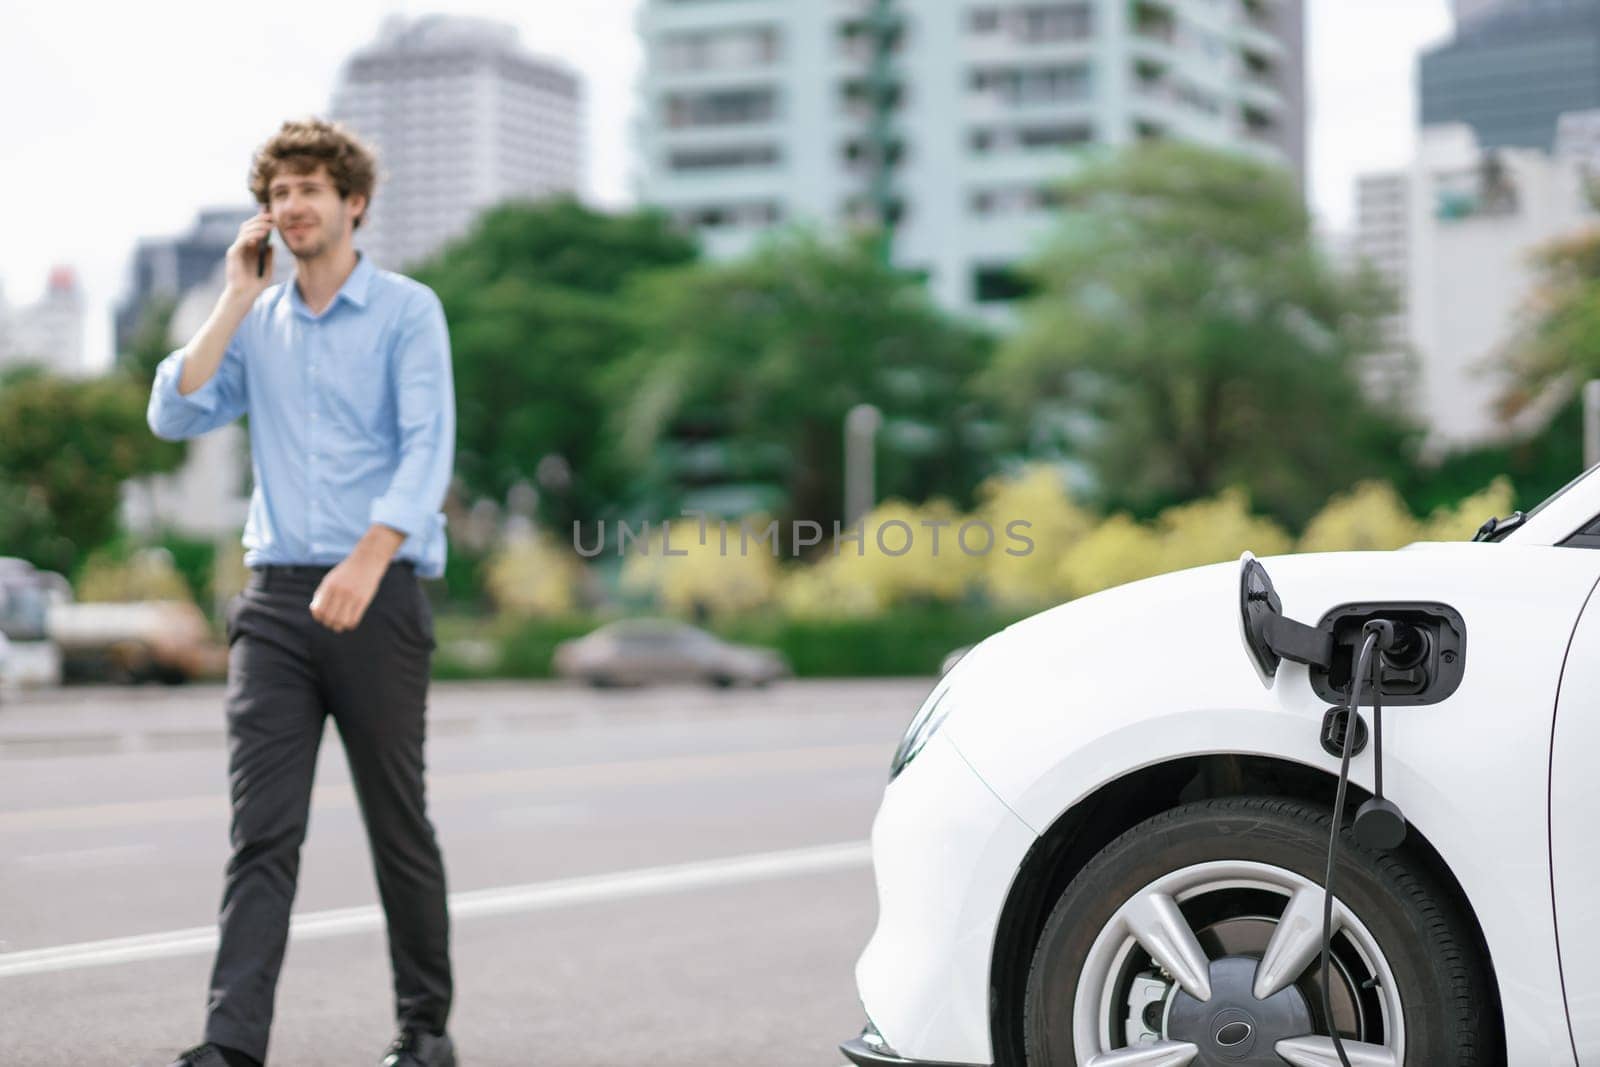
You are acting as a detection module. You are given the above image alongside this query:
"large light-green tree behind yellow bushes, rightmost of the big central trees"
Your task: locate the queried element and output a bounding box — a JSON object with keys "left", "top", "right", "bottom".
{"left": 984, "top": 142, "right": 1410, "bottom": 528}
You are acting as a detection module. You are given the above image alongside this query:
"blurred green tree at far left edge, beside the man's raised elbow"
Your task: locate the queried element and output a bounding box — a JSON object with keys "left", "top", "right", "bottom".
{"left": 0, "top": 368, "right": 182, "bottom": 573}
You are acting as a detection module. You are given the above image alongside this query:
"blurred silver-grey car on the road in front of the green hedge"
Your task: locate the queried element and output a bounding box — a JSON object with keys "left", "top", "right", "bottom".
{"left": 552, "top": 619, "right": 792, "bottom": 686}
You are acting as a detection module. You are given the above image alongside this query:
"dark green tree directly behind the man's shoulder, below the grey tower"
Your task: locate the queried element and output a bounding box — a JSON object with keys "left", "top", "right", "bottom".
{"left": 416, "top": 200, "right": 696, "bottom": 526}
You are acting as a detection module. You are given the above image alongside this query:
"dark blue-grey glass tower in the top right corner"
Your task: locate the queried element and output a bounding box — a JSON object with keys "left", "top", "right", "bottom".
{"left": 1419, "top": 0, "right": 1600, "bottom": 152}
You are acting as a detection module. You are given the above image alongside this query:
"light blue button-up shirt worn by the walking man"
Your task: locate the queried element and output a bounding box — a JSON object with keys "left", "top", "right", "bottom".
{"left": 149, "top": 254, "right": 456, "bottom": 577}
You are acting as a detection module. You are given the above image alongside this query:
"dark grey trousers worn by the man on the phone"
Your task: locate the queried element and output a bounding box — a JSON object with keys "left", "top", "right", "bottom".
{"left": 205, "top": 563, "right": 451, "bottom": 1061}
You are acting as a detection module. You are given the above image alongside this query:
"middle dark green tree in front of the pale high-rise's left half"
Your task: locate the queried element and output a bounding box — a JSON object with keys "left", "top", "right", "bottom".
{"left": 611, "top": 232, "right": 990, "bottom": 537}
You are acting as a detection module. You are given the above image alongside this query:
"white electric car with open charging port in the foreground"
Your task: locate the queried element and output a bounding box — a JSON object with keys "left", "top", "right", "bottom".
{"left": 843, "top": 467, "right": 1600, "bottom": 1067}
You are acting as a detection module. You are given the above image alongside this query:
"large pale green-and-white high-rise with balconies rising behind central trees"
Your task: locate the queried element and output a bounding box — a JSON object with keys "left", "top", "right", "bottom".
{"left": 638, "top": 0, "right": 1304, "bottom": 309}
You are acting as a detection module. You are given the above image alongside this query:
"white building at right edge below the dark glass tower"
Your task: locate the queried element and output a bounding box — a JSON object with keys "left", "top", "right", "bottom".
{"left": 1357, "top": 125, "right": 1600, "bottom": 453}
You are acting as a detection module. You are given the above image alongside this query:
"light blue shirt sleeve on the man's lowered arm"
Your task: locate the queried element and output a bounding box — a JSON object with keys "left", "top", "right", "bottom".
{"left": 371, "top": 291, "right": 456, "bottom": 537}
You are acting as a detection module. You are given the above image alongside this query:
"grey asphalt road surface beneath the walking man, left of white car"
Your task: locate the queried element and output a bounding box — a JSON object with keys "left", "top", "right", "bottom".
{"left": 0, "top": 678, "right": 931, "bottom": 1067}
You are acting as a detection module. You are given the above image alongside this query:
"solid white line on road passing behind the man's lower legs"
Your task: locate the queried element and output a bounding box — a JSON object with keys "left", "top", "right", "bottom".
{"left": 0, "top": 841, "right": 872, "bottom": 977}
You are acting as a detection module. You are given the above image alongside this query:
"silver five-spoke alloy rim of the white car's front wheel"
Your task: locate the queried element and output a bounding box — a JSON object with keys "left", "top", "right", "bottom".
{"left": 1072, "top": 861, "right": 1405, "bottom": 1067}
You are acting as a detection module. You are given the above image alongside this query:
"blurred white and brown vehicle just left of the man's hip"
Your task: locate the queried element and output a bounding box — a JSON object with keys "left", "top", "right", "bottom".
{"left": 48, "top": 600, "right": 227, "bottom": 685}
